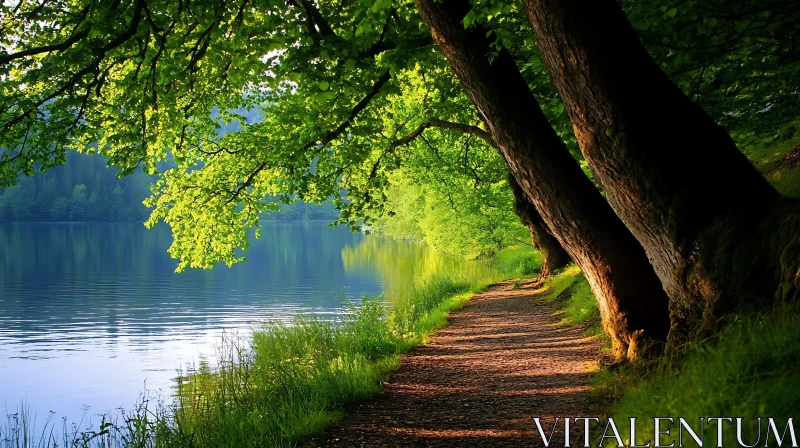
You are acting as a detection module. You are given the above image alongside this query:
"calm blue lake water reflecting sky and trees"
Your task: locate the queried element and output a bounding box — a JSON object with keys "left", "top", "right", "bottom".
{"left": 0, "top": 222, "right": 444, "bottom": 421}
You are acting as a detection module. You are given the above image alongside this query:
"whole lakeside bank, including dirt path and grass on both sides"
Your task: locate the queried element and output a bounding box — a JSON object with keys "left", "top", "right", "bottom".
{"left": 0, "top": 242, "right": 800, "bottom": 448}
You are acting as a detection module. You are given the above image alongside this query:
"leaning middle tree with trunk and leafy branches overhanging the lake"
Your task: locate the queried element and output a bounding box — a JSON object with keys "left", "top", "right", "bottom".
{"left": 0, "top": 0, "right": 667, "bottom": 358}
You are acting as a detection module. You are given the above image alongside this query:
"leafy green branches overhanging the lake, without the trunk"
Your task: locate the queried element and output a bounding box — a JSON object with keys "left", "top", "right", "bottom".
{"left": 0, "top": 0, "right": 556, "bottom": 269}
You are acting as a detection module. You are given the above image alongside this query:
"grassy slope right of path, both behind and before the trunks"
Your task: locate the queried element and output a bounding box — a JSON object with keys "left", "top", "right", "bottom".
{"left": 528, "top": 266, "right": 800, "bottom": 446}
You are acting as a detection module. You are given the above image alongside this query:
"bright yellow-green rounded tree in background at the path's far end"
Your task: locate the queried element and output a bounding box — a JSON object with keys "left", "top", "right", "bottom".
{"left": 376, "top": 128, "right": 530, "bottom": 258}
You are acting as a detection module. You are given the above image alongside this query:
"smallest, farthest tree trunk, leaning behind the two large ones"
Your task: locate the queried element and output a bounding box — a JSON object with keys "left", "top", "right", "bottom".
{"left": 508, "top": 171, "right": 571, "bottom": 284}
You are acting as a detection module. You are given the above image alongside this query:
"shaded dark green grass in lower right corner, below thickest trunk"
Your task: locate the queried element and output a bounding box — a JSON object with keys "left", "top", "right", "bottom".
{"left": 596, "top": 308, "right": 800, "bottom": 446}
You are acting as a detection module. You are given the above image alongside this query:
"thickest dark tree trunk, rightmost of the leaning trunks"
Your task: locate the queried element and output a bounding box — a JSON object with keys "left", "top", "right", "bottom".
{"left": 525, "top": 0, "right": 800, "bottom": 334}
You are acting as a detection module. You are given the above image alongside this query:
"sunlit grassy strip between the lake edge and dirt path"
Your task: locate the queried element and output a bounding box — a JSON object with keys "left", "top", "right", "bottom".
{"left": 0, "top": 248, "right": 538, "bottom": 448}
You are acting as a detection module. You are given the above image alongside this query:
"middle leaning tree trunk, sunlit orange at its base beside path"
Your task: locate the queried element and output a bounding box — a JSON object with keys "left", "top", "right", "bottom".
{"left": 416, "top": 0, "right": 669, "bottom": 359}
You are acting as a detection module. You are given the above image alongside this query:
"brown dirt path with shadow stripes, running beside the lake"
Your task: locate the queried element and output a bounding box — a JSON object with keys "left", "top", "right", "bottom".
{"left": 315, "top": 282, "right": 599, "bottom": 447}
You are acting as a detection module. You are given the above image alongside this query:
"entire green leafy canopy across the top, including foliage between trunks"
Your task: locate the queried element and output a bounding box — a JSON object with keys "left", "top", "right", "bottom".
{"left": 0, "top": 0, "right": 800, "bottom": 269}
